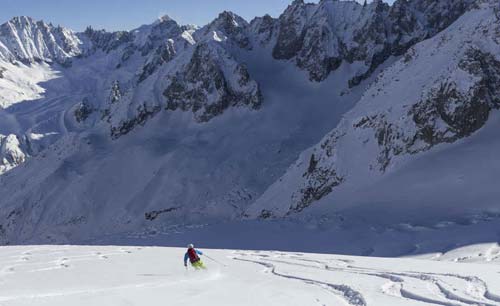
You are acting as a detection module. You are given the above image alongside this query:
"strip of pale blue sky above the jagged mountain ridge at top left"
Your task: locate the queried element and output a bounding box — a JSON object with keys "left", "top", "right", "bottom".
{"left": 0, "top": 0, "right": 393, "bottom": 31}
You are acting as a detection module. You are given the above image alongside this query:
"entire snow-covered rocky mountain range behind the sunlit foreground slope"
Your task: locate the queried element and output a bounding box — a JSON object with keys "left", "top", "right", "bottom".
{"left": 0, "top": 0, "right": 500, "bottom": 244}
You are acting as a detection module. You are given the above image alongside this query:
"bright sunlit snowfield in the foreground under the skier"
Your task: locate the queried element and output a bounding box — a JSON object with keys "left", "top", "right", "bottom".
{"left": 0, "top": 246, "right": 500, "bottom": 306}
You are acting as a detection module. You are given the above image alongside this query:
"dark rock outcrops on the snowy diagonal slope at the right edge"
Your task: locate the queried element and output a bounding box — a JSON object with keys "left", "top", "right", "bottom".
{"left": 356, "top": 45, "right": 500, "bottom": 171}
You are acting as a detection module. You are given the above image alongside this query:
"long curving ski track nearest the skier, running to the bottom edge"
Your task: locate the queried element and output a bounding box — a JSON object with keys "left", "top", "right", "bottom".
{"left": 233, "top": 258, "right": 367, "bottom": 306}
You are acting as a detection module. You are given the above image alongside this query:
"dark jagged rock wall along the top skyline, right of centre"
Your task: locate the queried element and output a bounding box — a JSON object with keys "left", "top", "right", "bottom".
{"left": 266, "top": 0, "right": 473, "bottom": 86}
